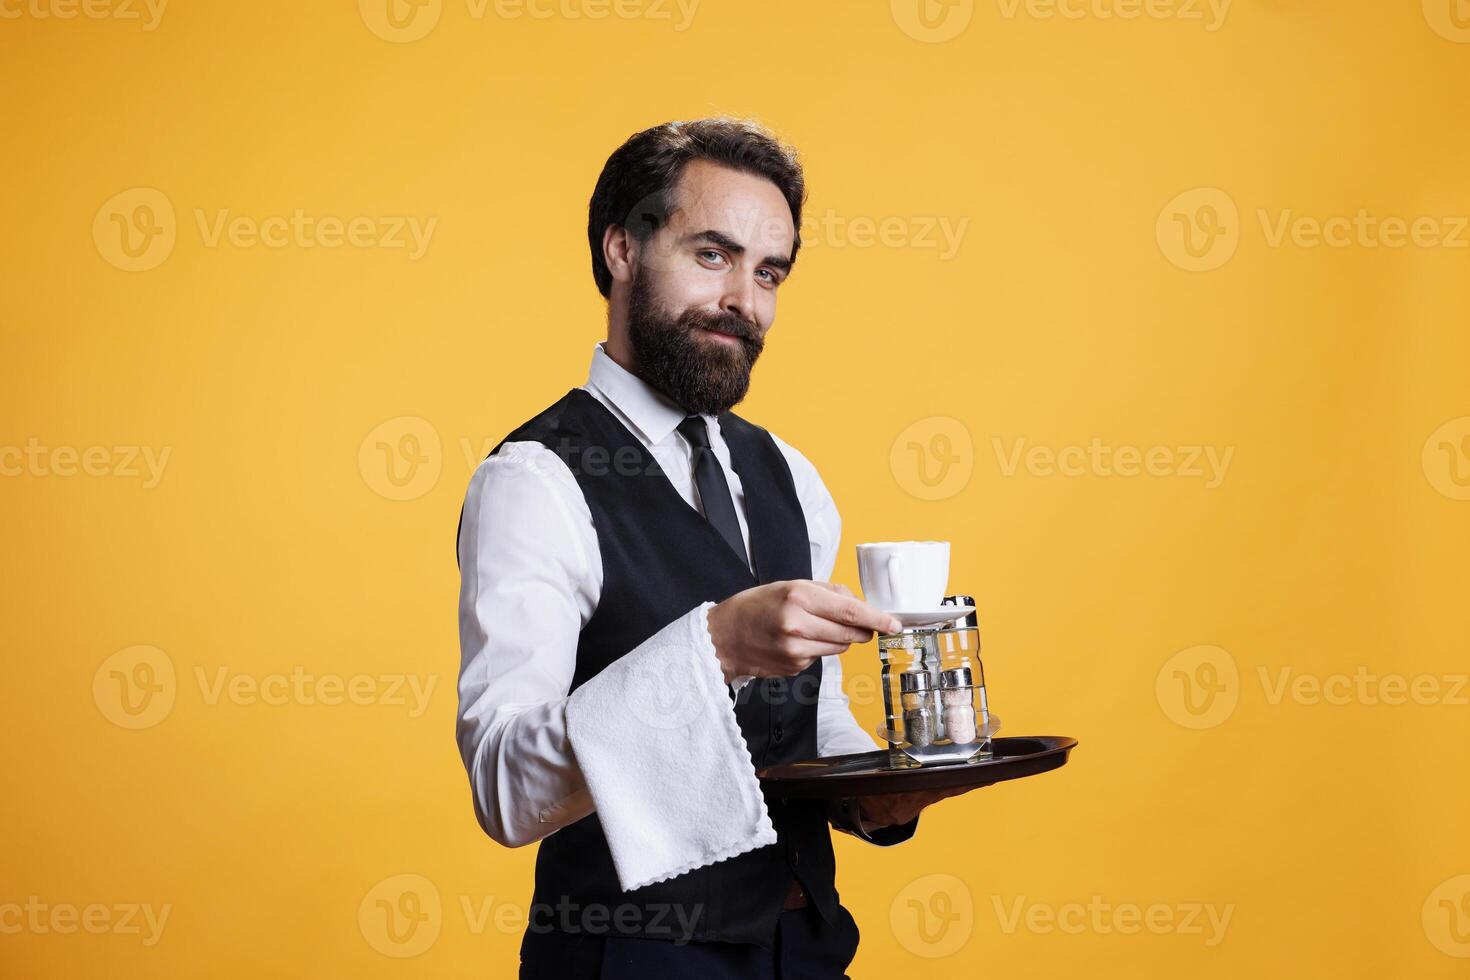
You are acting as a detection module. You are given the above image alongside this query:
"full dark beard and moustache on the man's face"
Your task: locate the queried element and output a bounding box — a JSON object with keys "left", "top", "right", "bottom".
{"left": 628, "top": 269, "right": 766, "bottom": 416}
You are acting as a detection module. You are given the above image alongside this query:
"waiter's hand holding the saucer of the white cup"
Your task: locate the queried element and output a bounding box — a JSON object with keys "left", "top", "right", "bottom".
{"left": 709, "top": 579, "right": 903, "bottom": 683}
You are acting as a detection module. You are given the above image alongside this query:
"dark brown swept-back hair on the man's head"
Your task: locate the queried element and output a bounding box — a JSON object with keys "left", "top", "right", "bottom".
{"left": 587, "top": 118, "right": 807, "bottom": 298}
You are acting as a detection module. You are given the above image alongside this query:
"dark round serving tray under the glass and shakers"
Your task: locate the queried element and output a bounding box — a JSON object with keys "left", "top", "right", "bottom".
{"left": 756, "top": 735, "right": 1078, "bottom": 799}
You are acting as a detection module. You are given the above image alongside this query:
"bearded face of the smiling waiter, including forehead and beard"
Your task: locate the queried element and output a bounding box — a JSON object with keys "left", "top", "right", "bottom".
{"left": 628, "top": 160, "right": 795, "bottom": 414}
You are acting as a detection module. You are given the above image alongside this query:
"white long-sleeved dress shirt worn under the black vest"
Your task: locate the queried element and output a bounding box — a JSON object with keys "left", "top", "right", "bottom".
{"left": 457, "top": 344, "right": 911, "bottom": 846}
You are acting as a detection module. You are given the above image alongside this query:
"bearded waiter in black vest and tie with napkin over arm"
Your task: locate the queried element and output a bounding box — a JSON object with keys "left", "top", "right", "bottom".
{"left": 457, "top": 119, "right": 948, "bottom": 980}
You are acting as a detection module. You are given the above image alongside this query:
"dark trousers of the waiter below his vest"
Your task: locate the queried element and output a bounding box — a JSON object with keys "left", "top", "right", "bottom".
{"left": 520, "top": 905, "right": 858, "bottom": 980}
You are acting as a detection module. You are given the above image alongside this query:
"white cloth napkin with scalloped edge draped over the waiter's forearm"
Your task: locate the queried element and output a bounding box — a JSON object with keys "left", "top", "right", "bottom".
{"left": 566, "top": 602, "right": 776, "bottom": 892}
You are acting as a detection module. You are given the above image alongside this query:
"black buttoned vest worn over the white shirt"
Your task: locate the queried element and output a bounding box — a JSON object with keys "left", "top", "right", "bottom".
{"left": 491, "top": 388, "right": 838, "bottom": 948}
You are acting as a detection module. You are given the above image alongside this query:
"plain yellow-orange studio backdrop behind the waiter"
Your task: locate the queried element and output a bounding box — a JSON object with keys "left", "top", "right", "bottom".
{"left": 0, "top": 0, "right": 1470, "bottom": 977}
